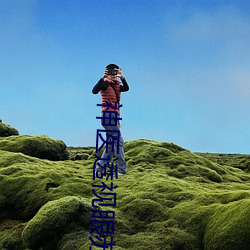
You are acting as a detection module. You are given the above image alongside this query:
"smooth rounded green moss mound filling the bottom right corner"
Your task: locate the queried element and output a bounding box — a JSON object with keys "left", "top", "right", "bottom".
{"left": 204, "top": 199, "right": 250, "bottom": 250}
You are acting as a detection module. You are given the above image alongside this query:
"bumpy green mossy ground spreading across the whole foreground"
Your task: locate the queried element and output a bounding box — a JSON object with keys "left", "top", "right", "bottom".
{"left": 0, "top": 140, "right": 250, "bottom": 250}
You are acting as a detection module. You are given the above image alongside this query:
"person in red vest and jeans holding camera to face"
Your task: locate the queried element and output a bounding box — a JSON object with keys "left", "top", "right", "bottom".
{"left": 92, "top": 64, "right": 129, "bottom": 176}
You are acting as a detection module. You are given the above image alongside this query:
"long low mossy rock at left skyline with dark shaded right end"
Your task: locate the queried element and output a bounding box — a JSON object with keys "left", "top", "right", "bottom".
{"left": 0, "top": 135, "right": 69, "bottom": 161}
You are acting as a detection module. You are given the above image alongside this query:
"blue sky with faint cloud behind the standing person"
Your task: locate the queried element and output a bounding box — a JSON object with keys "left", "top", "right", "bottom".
{"left": 0, "top": 0, "right": 250, "bottom": 154}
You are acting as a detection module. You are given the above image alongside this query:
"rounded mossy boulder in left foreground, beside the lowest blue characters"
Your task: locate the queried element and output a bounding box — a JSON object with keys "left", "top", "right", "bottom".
{"left": 22, "top": 196, "right": 91, "bottom": 249}
